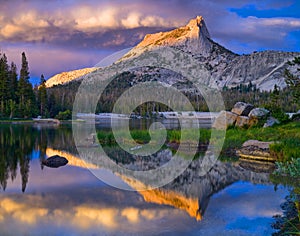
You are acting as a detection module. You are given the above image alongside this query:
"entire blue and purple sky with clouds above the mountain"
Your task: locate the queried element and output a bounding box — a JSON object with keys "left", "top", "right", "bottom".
{"left": 0, "top": 0, "right": 300, "bottom": 82}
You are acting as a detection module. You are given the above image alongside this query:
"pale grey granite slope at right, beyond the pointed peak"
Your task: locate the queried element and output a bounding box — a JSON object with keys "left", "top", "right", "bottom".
{"left": 218, "top": 51, "right": 300, "bottom": 90}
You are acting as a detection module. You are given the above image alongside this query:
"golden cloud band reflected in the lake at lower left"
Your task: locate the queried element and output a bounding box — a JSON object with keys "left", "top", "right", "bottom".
{"left": 0, "top": 194, "right": 188, "bottom": 235}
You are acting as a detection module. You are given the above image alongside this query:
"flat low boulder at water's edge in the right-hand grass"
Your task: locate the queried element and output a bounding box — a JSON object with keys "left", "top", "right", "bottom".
{"left": 237, "top": 140, "right": 276, "bottom": 162}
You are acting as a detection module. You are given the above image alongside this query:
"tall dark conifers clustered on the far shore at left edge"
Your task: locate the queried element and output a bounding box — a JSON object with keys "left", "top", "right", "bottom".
{"left": 0, "top": 52, "right": 49, "bottom": 119}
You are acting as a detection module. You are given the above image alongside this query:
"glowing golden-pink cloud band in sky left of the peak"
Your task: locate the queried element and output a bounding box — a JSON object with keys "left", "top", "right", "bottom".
{"left": 0, "top": 1, "right": 178, "bottom": 47}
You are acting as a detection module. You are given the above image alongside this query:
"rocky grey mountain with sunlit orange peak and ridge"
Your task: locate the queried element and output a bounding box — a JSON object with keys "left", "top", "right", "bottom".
{"left": 47, "top": 16, "right": 300, "bottom": 91}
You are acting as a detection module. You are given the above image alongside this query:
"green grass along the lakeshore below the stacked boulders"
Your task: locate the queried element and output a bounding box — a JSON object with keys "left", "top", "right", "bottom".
{"left": 98, "top": 122, "right": 300, "bottom": 162}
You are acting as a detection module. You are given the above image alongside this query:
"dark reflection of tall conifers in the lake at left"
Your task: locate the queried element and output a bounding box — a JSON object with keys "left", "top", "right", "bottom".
{"left": 0, "top": 125, "right": 74, "bottom": 192}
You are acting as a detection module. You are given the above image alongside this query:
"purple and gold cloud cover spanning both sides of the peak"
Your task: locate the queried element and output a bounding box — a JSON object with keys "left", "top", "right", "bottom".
{"left": 0, "top": 0, "right": 299, "bottom": 53}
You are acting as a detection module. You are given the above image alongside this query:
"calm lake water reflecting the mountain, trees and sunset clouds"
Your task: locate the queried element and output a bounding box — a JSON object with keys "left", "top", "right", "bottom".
{"left": 0, "top": 125, "right": 289, "bottom": 235}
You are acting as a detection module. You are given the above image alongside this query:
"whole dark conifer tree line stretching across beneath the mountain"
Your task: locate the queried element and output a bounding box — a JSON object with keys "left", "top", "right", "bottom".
{"left": 0, "top": 52, "right": 300, "bottom": 119}
